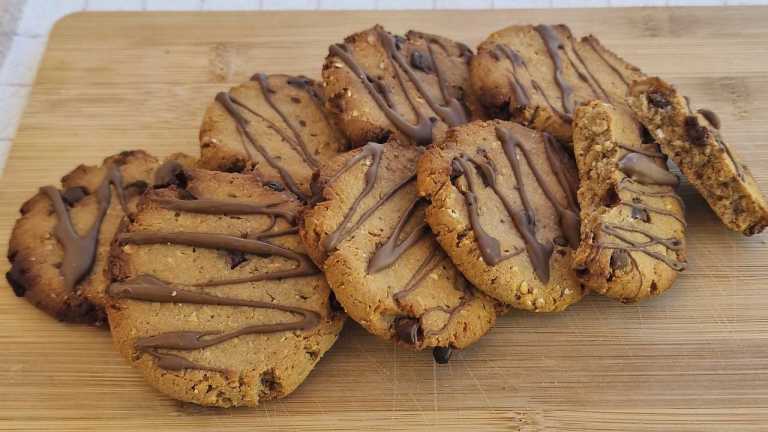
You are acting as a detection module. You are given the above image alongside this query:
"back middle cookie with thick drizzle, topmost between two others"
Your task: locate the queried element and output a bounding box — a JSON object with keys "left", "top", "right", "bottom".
{"left": 323, "top": 25, "right": 472, "bottom": 146}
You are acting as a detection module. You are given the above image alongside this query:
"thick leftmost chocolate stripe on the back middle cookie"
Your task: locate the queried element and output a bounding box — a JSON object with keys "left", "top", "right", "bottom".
{"left": 328, "top": 44, "right": 432, "bottom": 145}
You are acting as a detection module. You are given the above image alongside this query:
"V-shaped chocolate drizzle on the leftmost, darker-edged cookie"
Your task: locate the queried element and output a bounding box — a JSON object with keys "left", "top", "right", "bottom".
{"left": 40, "top": 165, "right": 128, "bottom": 290}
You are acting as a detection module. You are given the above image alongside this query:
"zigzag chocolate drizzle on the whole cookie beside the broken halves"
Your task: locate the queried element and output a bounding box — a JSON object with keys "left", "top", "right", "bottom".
{"left": 454, "top": 127, "right": 580, "bottom": 283}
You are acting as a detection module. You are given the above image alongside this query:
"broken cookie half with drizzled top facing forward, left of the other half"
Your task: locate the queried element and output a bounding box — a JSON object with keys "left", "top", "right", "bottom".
{"left": 573, "top": 101, "right": 686, "bottom": 302}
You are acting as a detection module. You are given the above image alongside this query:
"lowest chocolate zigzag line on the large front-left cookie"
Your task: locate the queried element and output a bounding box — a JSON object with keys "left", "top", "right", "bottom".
{"left": 107, "top": 275, "right": 321, "bottom": 372}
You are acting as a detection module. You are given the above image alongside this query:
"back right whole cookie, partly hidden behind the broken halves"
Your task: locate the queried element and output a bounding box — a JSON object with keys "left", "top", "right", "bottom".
{"left": 470, "top": 24, "right": 644, "bottom": 142}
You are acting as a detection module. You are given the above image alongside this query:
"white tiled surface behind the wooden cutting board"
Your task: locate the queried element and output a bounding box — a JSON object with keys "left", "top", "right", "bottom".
{"left": 0, "top": 0, "right": 768, "bottom": 173}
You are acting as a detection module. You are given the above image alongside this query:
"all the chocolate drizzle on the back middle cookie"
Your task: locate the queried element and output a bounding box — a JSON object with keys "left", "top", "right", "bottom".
{"left": 329, "top": 27, "right": 468, "bottom": 145}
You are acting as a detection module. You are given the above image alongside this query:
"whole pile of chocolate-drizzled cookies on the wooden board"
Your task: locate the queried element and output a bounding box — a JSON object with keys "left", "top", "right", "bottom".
{"left": 6, "top": 25, "right": 768, "bottom": 407}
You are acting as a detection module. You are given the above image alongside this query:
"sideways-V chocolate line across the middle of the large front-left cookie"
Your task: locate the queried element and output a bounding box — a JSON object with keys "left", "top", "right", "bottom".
{"left": 117, "top": 231, "right": 320, "bottom": 287}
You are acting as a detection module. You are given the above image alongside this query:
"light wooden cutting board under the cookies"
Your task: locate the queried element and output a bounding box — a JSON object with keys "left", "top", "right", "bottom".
{"left": 0, "top": 7, "right": 768, "bottom": 432}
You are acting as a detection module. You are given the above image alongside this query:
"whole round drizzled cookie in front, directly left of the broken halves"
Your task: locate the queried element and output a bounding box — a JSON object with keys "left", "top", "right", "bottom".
{"left": 418, "top": 121, "right": 585, "bottom": 312}
